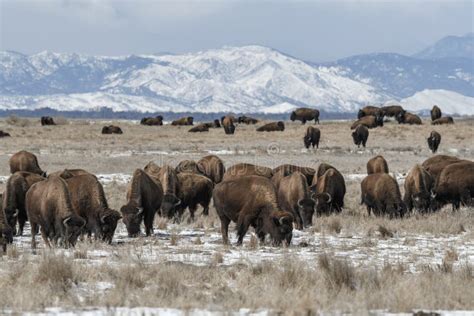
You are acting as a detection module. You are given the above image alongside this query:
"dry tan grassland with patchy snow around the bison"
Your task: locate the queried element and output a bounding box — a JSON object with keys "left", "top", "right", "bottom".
{"left": 0, "top": 119, "right": 474, "bottom": 314}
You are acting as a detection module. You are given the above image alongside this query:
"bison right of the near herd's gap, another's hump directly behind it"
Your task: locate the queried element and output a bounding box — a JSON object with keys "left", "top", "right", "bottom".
{"left": 360, "top": 173, "right": 406, "bottom": 218}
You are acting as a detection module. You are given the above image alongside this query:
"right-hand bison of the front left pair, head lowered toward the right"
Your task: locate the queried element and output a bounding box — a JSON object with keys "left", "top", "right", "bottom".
{"left": 66, "top": 174, "right": 122, "bottom": 244}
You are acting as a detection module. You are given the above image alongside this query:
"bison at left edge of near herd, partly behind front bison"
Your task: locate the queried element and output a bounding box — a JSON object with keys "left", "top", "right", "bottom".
{"left": 0, "top": 171, "right": 45, "bottom": 236}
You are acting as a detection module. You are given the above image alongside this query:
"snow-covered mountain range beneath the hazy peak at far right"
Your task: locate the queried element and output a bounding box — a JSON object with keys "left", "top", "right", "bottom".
{"left": 0, "top": 38, "right": 474, "bottom": 114}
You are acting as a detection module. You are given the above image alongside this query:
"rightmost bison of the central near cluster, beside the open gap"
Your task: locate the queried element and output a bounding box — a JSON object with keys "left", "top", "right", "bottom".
{"left": 313, "top": 169, "right": 346, "bottom": 215}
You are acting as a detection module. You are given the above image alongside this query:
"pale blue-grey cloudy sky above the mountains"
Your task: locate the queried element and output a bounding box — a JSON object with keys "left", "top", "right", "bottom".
{"left": 0, "top": 0, "right": 474, "bottom": 62}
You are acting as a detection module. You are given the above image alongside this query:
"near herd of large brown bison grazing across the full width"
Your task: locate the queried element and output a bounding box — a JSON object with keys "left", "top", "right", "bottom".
{"left": 0, "top": 146, "right": 474, "bottom": 249}
